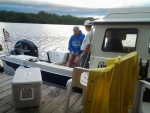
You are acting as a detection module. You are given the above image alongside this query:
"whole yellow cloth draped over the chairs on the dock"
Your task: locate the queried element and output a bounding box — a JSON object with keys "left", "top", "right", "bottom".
{"left": 83, "top": 52, "right": 139, "bottom": 113}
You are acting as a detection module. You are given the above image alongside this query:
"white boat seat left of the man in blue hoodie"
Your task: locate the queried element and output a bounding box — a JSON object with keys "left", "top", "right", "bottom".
{"left": 47, "top": 51, "right": 69, "bottom": 65}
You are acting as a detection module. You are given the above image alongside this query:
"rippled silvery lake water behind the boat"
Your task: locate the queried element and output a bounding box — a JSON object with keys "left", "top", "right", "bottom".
{"left": 0, "top": 22, "right": 86, "bottom": 60}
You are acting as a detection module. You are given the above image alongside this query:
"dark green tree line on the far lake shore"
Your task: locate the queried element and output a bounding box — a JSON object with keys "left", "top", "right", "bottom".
{"left": 0, "top": 10, "right": 94, "bottom": 25}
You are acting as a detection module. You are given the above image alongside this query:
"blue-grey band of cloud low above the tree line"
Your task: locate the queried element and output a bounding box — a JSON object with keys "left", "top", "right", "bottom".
{"left": 0, "top": 4, "right": 107, "bottom": 17}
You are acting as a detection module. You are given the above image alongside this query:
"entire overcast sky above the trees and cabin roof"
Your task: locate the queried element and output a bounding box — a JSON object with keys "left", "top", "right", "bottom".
{"left": 0, "top": 0, "right": 150, "bottom": 17}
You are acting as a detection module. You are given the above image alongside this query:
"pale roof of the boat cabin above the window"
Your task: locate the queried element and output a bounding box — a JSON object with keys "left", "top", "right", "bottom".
{"left": 93, "top": 7, "right": 150, "bottom": 25}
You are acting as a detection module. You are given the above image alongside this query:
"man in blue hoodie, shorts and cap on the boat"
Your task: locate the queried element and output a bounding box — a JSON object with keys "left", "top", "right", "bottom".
{"left": 66, "top": 26, "right": 85, "bottom": 67}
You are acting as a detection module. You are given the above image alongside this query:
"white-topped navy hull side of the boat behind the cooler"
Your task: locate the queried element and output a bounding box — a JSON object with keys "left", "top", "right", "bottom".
{"left": 1, "top": 55, "right": 73, "bottom": 87}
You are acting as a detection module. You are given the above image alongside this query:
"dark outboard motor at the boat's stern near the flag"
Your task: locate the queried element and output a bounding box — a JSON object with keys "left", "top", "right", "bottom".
{"left": 11, "top": 39, "right": 38, "bottom": 57}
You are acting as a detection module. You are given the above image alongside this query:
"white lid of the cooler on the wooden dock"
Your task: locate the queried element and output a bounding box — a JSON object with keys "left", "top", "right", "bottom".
{"left": 12, "top": 67, "right": 42, "bottom": 84}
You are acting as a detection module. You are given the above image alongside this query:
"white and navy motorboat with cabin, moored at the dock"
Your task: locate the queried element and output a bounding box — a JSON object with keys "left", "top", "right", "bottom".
{"left": 1, "top": 7, "right": 150, "bottom": 87}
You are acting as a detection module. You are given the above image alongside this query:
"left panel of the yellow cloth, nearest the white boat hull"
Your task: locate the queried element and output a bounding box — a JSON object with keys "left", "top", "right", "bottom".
{"left": 83, "top": 65, "right": 114, "bottom": 113}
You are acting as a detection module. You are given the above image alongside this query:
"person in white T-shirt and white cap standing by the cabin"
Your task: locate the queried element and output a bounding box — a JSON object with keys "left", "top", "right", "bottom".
{"left": 80, "top": 20, "right": 92, "bottom": 68}
